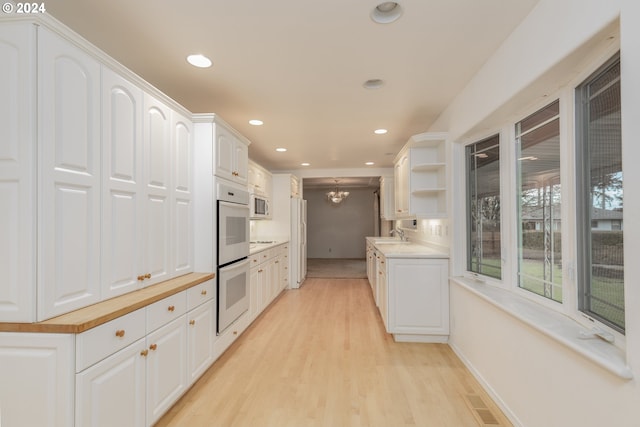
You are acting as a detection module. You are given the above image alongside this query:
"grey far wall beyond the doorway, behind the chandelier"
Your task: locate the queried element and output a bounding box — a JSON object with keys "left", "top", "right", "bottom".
{"left": 304, "top": 188, "right": 375, "bottom": 259}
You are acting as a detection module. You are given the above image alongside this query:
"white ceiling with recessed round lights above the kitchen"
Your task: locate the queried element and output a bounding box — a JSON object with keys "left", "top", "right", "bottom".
{"left": 46, "top": 0, "right": 537, "bottom": 170}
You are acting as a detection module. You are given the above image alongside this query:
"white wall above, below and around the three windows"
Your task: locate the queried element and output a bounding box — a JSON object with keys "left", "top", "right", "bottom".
{"left": 410, "top": 0, "right": 640, "bottom": 427}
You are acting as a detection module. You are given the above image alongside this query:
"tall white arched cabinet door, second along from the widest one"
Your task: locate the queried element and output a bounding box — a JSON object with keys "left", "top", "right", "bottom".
{"left": 101, "top": 68, "right": 144, "bottom": 299}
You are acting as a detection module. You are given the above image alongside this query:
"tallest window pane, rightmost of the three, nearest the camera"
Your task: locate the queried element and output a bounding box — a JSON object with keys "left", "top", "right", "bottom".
{"left": 576, "top": 57, "right": 625, "bottom": 332}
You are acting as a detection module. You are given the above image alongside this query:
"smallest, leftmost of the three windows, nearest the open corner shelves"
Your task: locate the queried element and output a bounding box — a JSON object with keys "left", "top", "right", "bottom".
{"left": 466, "top": 135, "right": 502, "bottom": 279}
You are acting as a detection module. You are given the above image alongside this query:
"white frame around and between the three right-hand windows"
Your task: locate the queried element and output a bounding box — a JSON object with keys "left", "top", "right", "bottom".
{"left": 452, "top": 43, "right": 628, "bottom": 350}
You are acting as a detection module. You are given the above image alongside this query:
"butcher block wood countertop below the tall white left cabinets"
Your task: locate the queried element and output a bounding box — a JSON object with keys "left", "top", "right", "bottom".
{"left": 0, "top": 273, "right": 215, "bottom": 334}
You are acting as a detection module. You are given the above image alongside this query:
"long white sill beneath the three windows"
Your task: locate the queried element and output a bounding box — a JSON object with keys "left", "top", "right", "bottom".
{"left": 451, "top": 277, "right": 633, "bottom": 380}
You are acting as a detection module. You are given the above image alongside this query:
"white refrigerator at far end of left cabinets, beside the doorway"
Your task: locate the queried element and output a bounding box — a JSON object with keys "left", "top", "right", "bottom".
{"left": 289, "top": 199, "right": 307, "bottom": 288}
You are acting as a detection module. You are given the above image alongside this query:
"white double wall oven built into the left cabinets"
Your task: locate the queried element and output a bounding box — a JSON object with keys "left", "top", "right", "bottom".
{"left": 216, "top": 182, "right": 250, "bottom": 334}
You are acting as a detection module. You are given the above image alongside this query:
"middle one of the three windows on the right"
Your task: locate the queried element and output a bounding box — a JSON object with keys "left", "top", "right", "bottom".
{"left": 515, "top": 101, "right": 562, "bottom": 302}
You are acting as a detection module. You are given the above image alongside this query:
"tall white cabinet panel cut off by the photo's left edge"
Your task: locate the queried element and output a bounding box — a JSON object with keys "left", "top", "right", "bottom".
{"left": 0, "top": 22, "right": 36, "bottom": 322}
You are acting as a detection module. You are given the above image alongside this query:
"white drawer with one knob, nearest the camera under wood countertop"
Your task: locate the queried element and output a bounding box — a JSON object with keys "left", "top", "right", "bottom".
{"left": 76, "top": 308, "right": 146, "bottom": 372}
